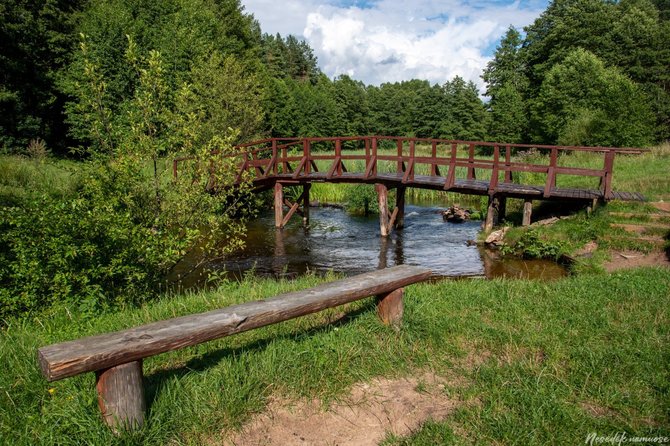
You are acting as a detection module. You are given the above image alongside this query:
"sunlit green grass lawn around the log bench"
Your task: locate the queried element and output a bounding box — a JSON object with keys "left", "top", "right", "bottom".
{"left": 0, "top": 269, "right": 670, "bottom": 445}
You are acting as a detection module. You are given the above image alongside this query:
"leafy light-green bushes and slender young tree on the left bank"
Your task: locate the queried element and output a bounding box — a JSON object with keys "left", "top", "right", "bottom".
{"left": 0, "top": 40, "right": 253, "bottom": 317}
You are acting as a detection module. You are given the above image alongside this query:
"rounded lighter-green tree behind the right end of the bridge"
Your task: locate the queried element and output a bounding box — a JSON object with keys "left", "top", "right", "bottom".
{"left": 532, "top": 49, "right": 654, "bottom": 146}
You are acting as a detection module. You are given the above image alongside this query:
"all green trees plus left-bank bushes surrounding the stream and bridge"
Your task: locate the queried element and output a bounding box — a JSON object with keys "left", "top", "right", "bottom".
{"left": 0, "top": 0, "right": 670, "bottom": 318}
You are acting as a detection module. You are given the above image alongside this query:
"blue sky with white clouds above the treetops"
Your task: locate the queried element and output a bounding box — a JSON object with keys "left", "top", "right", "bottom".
{"left": 242, "top": 0, "right": 548, "bottom": 88}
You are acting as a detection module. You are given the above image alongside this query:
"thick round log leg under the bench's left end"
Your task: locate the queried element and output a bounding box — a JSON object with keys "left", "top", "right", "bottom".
{"left": 95, "top": 360, "right": 146, "bottom": 433}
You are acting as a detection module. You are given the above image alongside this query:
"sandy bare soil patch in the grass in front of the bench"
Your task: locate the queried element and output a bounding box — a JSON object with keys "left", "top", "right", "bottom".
{"left": 224, "top": 373, "right": 463, "bottom": 446}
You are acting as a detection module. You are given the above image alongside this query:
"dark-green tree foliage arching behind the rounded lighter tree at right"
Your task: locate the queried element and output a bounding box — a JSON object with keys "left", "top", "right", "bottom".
{"left": 521, "top": 0, "right": 670, "bottom": 141}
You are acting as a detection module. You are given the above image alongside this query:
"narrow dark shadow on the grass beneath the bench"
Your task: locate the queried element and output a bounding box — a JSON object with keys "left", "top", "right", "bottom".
{"left": 145, "top": 300, "right": 376, "bottom": 416}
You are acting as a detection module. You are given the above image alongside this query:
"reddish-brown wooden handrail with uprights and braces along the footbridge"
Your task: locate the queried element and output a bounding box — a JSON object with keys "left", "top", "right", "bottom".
{"left": 173, "top": 135, "right": 648, "bottom": 199}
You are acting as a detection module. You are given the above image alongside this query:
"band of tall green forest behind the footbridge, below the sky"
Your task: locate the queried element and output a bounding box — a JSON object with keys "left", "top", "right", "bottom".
{"left": 0, "top": 0, "right": 670, "bottom": 155}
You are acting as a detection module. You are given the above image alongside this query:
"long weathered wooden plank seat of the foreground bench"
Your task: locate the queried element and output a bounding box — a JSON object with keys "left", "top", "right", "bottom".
{"left": 38, "top": 265, "right": 431, "bottom": 381}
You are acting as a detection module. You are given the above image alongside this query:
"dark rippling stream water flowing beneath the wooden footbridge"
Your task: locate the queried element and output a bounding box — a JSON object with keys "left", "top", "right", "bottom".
{"left": 172, "top": 205, "right": 566, "bottom": 288}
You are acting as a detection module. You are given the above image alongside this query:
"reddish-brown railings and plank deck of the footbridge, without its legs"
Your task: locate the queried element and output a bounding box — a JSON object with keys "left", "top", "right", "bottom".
{"left": 173, "top": 136, "right": 648, "bottom": 205}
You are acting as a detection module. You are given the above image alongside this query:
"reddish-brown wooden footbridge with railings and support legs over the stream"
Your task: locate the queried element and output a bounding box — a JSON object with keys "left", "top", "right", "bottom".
{"left": 173, "top": 136, "right": 644, "bottom": 236}
